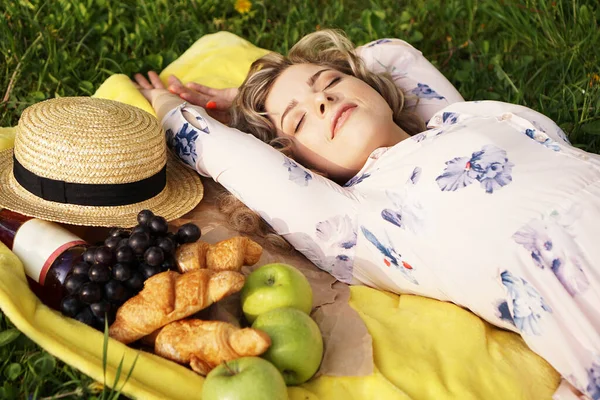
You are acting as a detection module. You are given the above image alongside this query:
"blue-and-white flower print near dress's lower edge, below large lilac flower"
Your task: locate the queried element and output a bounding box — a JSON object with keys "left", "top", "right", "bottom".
{"left": 500, "top": 271, "right": 552, "bottom": 336}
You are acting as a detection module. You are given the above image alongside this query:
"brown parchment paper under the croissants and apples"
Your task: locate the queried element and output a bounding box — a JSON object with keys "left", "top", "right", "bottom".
{"left": 72, "top": 178, "right": 374, "bottom": 376}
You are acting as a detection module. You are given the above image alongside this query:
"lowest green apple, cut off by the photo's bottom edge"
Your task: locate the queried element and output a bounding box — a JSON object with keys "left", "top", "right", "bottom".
{"left": 202, "top": 357, "right": 288, "bottom": 400}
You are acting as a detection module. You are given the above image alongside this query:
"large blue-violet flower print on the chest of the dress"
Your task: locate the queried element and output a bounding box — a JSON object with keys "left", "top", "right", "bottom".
{"left": 436, "top": 144, "right": 514, "bottom": 193}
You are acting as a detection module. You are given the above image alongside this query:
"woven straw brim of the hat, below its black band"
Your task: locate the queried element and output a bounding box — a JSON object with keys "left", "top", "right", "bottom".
{"left": 0, "top": 149, "right": 204, "bottom": 228}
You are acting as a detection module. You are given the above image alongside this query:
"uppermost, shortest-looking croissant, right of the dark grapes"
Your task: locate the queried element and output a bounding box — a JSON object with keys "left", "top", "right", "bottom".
{"left": 175, "top": 236, "right": 262, "bottom": 273}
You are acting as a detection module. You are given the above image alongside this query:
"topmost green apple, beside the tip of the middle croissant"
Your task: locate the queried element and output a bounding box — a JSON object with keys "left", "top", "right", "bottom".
{"left": 242, "top": 263, "right": 312, "bottom": 323}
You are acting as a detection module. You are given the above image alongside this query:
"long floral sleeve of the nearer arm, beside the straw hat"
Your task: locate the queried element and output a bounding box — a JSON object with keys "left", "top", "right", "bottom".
{"left": 162, "top": 103, "right": 357, "bottom": 282}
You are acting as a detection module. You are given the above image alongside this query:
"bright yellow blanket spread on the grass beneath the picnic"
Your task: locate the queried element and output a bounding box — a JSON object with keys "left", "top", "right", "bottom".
{"left": 0, "top": 32, "right": 560, "bottom": 400}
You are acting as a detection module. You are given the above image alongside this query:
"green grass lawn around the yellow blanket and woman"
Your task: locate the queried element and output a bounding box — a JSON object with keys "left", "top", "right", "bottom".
{"left": 0, "top": 0, "right": 600, "bottom": 398}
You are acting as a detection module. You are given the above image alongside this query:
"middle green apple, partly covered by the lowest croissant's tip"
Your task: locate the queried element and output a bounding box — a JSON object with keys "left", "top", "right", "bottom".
{"left": 252, "top": 307, "right": 323, "bottom": 385}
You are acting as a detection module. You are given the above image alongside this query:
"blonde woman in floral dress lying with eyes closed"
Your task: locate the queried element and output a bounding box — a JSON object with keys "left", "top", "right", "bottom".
{"left": 136, "top": 30, "right": 600, "bottom": 399}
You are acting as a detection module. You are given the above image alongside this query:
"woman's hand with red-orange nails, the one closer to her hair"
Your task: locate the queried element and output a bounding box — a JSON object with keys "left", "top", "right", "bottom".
{"left": 168, "top": 75, "right": 238, "bottom": 124}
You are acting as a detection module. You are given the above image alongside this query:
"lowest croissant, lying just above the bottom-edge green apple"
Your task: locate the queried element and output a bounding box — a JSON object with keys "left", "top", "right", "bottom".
{"left": 154, "top": 319, "right": 271, "bottom": 375}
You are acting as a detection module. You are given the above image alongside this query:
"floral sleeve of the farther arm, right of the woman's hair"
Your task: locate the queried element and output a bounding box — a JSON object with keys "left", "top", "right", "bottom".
{"left": 356, "top": 39, "right": 464, "bottom": 122}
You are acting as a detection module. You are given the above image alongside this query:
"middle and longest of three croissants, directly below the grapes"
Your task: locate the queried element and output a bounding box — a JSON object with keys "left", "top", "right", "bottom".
{"left": 109, "top": 269, "right": 245, "bottom": 344}
